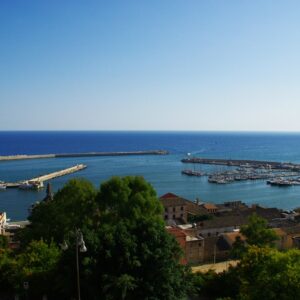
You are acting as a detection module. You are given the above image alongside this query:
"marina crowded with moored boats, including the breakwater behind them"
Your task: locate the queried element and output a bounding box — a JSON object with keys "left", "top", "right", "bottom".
{"left": 182, "top": 158, "right": 300, "bottom": 187}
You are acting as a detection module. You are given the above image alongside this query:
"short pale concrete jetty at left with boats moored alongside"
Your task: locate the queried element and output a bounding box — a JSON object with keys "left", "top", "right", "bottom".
{"left": 1, "top": 164, "right": 87, "bottom": 189}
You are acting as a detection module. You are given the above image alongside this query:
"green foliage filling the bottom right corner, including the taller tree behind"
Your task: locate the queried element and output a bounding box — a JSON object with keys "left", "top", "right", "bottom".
{"left": 192, "top": 215, "right": 300, "bottom": 300}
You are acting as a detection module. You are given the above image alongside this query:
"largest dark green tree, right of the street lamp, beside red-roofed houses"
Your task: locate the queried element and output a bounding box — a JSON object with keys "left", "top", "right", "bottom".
{"left": 86, "top": 177, "right": 186, "bottom": 299}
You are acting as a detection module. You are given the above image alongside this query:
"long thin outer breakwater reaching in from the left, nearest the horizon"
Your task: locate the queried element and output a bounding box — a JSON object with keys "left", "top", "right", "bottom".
{"left": 0, "top": 150, "right": 169, "bottom": 161}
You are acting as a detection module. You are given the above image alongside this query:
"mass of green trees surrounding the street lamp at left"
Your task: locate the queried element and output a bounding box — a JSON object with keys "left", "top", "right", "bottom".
{"left": 0, "top": 177, "right": 188, "bottom": 300}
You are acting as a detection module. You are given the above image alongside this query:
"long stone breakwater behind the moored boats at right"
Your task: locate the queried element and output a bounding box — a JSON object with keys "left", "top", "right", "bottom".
{"left": 181, "top": 157, "right": 300, "bottom": 171}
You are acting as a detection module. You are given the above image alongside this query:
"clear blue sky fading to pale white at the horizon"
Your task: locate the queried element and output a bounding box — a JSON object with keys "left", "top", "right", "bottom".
{"left": 0, "top": 0, "right": 300, "bottom": 131}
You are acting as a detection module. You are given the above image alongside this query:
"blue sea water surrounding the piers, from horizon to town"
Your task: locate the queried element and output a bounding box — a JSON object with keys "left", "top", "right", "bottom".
{"left": 0, "top": 131, "right": 300, "bottom": 220}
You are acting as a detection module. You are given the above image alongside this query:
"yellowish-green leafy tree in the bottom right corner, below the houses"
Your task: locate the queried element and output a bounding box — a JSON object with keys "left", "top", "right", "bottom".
{"left": 238, "top": 246, "right": 300, "bottom": 300}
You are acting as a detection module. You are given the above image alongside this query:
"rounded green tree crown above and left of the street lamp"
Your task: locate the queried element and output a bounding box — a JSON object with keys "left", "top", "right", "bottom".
{"left": 20, "top": 179, "right": 97, "bottom": 244}
